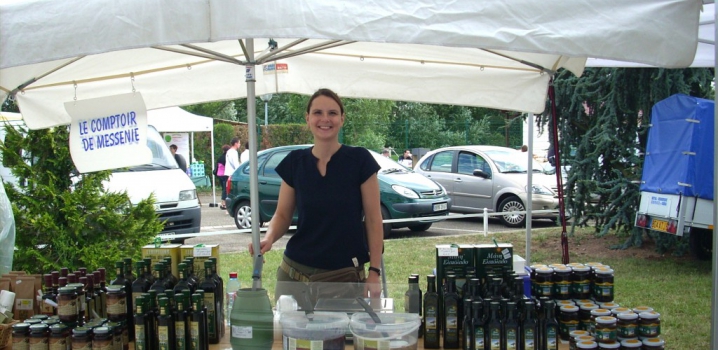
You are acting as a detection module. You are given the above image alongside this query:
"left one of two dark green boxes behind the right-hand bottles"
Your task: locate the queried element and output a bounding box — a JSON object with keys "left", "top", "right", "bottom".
{"left": 436, "top": 244, "right": 476, "bottom": 290}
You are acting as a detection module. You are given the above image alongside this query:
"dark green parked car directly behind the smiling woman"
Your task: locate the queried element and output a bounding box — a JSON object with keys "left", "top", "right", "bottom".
{"left": 226, "top": 145, "right": 451, "bottom": 237}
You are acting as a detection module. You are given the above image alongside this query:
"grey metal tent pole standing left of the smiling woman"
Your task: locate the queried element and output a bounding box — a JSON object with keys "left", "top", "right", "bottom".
{"left": 245, "top": 39, "right": 262, "bottom": 289}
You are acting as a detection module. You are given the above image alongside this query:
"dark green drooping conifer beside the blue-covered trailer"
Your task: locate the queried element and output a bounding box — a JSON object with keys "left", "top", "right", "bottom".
{"left": 544, "top": 68, "right": 713, "bottom": 252}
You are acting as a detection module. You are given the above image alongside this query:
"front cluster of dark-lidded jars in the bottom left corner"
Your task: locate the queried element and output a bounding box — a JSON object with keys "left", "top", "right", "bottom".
{"left": 12, "top": 315, "right": 129, "bottom": 350}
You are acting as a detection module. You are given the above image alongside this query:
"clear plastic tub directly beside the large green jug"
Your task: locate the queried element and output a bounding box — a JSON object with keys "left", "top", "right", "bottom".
{"left": 279, "top": 311, "right": 349, "bottom": 350}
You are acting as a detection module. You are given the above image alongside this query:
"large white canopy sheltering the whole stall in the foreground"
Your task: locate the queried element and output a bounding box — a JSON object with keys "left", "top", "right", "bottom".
{"left": 0, "top": 0, "right": 716, "bottom": 344}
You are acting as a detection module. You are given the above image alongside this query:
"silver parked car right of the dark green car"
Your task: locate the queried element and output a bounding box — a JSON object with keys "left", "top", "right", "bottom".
{"left": 414, "top": 146, "right": 559, "bottom": 227}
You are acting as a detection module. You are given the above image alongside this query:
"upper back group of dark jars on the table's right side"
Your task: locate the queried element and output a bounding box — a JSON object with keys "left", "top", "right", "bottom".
{"left": 531, "top": 262, "right": 614, "bottom": 302}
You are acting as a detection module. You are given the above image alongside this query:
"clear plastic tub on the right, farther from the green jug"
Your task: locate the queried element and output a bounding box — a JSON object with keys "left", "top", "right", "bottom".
{"left": 349, "top": 312, "right": 421, "bottom": 350}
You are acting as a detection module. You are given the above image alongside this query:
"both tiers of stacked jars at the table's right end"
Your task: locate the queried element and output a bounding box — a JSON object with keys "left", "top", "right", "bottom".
{"left": 531, "top": 262, "right": 665, "bottom": 349}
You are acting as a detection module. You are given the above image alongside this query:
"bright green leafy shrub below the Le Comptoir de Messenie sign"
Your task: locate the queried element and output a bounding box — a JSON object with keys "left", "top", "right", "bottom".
{"left": 0, "top": 125, "right": 163, "bottom": 273}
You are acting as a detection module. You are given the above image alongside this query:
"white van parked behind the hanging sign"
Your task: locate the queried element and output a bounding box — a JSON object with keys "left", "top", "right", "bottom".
{"left": 0, "top": 116, "right": 201, "bottom": 242}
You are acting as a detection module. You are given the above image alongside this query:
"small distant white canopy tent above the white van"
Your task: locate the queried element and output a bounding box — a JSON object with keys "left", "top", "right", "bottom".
{"left": 147, "top": 107, "right": 217, "bottom": 204}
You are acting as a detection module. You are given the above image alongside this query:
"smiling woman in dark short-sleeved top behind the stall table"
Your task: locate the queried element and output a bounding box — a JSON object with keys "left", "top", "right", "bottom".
{"left": 249, "top": 89, "right": 383, "bottom": 300}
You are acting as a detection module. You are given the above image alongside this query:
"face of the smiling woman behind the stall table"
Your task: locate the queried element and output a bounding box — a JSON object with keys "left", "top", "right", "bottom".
{"left": 305, "top": 96, "right": 344, "bottom": 140}
